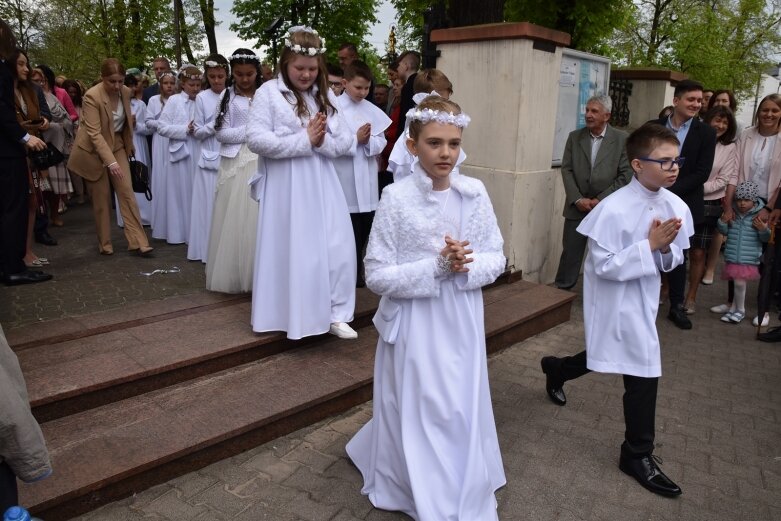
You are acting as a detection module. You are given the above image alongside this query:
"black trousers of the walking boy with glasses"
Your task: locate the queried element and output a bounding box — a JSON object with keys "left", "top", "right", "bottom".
{"left": 559, "top": 351, "right": 659, "bottom": 458}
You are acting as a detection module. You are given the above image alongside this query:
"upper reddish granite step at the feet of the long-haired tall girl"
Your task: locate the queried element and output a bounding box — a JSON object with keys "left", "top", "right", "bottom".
{"left": 9, "top": 289, "right": 379, "bottom": 421}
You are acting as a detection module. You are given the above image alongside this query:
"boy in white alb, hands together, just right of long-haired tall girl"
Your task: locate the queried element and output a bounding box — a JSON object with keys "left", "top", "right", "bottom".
{"left": 334, "top": 61, "right": 391, "bottom": 287}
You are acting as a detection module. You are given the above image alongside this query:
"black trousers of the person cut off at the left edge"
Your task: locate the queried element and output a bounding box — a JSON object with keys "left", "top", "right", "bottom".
{"left": 0, "top": 157, "right": 30, "bottom": 274}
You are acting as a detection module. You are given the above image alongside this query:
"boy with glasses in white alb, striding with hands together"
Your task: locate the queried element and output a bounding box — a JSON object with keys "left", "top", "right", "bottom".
{"left": 541, "top": 123, "right": 694, "bottom": 496}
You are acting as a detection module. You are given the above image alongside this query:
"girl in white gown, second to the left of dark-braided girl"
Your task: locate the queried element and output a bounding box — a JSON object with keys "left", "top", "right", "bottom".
{"left": 157, "top": 66, "right": 202, "bottom": 244}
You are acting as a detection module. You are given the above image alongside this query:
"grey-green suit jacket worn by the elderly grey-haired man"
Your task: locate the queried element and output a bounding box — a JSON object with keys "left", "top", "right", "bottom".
{"left": 561, "top": 125, "right": 632, "bottom": 219}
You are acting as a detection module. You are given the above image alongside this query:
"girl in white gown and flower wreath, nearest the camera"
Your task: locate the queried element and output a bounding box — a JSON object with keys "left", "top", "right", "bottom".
{"left": 347, "top": 97, "right": 506, "bottom": 521}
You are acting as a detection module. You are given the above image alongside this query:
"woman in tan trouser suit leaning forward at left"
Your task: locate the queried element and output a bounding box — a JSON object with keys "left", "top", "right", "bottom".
{"left": 68, "top": 58, "right": 153, "bottom": 255}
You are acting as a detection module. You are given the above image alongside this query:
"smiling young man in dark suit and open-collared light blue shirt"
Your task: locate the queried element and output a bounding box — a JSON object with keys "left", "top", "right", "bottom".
{"left": 651, "top": 80, "right": 716, "bottom": 329}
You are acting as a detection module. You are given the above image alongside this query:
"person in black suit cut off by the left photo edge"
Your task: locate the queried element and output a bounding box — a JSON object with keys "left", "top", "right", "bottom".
{"left": 0, "top": 20, "right": 52, "bottom": 286}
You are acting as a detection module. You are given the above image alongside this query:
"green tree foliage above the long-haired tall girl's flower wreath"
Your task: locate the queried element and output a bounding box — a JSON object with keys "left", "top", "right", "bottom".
{"left": 230, "top": 0, "right": 377, "bottom": 61}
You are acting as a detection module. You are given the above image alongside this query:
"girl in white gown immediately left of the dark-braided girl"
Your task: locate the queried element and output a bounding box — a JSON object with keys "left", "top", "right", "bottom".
{"left": 187, "top": 54, "right": 228, "bottom": 263}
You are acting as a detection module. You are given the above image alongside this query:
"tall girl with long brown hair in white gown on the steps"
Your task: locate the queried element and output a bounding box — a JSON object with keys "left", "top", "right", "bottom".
{"left": 247, "top": 27, "right": 357, "bottom": 339}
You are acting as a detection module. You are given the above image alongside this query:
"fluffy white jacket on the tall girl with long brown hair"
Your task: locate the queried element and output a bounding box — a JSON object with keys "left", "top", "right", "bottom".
{"left": 247, "top": 76, "right": 356, "bottom": 159}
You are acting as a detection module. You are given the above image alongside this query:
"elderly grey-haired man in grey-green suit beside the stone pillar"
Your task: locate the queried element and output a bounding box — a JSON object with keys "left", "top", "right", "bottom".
{"left": 555, "top": 95, "right": 632, "bottom": 289}
